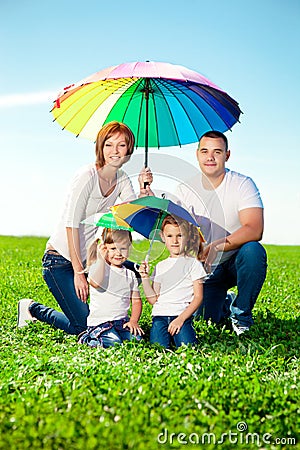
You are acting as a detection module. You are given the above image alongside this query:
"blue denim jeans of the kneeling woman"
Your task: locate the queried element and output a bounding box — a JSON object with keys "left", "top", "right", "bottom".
{"left": 29, "top": 252, "right": 89, "bottom": 335}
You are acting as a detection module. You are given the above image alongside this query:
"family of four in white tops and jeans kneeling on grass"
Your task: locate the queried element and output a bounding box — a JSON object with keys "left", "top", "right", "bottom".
{"left": 18, "top": 121, "right": 267, "bottom": 348}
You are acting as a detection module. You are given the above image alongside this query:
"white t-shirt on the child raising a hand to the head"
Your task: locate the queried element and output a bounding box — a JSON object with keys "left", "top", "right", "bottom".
{"left": 87, "top": 263, "right": 139, "bottom": 326}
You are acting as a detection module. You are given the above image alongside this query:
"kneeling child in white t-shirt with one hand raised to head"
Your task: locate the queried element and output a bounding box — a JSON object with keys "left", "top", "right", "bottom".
{"left": 78, "top": 228, "right": 143, "bottom": 348}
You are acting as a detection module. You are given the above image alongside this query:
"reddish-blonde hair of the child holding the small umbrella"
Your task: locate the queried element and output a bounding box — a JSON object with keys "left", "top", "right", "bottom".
{"left": 161, "top": 215, "right": 203, "bottom": 261}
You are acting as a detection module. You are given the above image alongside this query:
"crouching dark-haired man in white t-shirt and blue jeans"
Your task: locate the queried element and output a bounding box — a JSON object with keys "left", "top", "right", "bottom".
{"left": 177, "top": 131, "right": 267, "bottom": 335}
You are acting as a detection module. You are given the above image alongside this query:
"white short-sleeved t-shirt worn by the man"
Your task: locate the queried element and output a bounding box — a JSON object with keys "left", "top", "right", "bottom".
{"left": 176, "top": 169, "right": 263, "bottom": 262}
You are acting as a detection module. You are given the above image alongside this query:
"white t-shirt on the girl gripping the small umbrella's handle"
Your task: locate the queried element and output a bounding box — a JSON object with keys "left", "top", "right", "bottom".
{"left": 151, "top": 256, "right": 206, "bottom": 316}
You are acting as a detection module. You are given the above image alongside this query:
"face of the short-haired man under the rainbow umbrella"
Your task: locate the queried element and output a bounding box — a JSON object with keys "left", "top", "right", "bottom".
{"left": 197, "top": 137, "right": 230, "bottom": 178}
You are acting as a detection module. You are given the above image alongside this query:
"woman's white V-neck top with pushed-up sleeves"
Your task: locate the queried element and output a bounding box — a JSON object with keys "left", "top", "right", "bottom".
{"left": 48, "top": 164, "right": 136, "bottom": 261}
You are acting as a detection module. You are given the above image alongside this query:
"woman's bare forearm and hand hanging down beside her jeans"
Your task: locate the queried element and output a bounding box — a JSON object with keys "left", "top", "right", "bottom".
{"left": 66, "top": 227, "right": 89, "bottom": 303}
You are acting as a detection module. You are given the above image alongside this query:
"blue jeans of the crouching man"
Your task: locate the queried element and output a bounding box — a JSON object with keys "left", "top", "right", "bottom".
{"left": 195, "top": 241, "right": 267, "bottom": 327}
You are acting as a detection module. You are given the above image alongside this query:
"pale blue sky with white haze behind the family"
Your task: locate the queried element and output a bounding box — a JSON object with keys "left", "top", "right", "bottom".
{"left": 0, "top": 0, "right": 300, "bottom": 244}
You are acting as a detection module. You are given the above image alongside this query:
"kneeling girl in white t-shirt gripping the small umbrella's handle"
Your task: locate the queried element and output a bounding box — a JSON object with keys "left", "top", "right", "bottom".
{"left": 140, "top": 216, "right": 206, "bottom": 348}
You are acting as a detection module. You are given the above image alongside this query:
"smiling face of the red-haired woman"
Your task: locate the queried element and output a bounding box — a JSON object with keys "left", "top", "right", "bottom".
{"left": 103, "top": 133, "right": 128, "bottom": 167}
